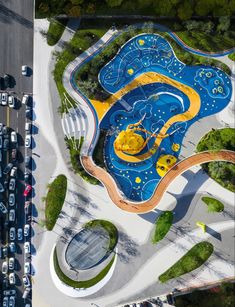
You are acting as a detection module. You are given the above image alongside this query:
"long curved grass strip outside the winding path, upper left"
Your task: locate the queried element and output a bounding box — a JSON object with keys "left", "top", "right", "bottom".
{"left": 53, "top": 29, "right": 107, "bottom": 113}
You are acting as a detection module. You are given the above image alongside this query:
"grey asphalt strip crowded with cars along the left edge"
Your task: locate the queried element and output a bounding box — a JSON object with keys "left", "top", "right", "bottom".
{"left": 0, "top": 0, "right": 35, "bottom": 306}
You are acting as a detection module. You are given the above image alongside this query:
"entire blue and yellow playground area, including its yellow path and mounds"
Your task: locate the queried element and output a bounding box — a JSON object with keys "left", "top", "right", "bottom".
{"left": 94, "top": 34, "right": 231, "bottom": 201}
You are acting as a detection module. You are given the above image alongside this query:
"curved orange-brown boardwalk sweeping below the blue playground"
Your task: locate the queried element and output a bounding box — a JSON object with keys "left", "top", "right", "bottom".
{"left": 81, "top": 150, "right": 235, "bottom": 213}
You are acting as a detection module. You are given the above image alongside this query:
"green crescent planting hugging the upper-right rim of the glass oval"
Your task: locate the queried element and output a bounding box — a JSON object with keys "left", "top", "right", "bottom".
{"left": 84, "top": 220, "right": 118, "bottom": 252}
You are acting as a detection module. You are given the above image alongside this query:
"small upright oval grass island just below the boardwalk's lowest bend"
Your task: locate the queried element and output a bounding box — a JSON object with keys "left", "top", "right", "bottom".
{"left": 152, "top": 211, "right": 173, "bottom": 244}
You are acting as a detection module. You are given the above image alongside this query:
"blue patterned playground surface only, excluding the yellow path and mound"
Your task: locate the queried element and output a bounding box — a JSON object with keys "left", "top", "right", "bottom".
{"left": 99, "top": 34, "right": 231, "bottom": 201}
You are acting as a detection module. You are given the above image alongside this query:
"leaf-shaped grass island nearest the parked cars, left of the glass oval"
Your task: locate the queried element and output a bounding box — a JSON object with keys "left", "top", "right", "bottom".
{"left": 45, "top": 175, "right": 67, "bottom": 230}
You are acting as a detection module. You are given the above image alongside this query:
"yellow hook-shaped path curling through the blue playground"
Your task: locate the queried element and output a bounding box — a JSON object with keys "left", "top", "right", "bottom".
{"left": 109, "top": 72, "right": 201, "bottom": 163}
